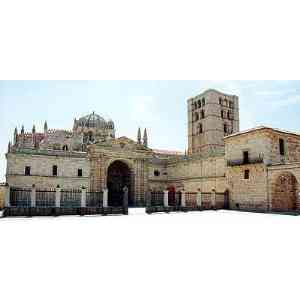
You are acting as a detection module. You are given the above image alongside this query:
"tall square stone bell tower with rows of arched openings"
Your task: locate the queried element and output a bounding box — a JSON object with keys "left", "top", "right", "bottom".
{"left": 187, "top": 89, "right": 240, "bottom": 155}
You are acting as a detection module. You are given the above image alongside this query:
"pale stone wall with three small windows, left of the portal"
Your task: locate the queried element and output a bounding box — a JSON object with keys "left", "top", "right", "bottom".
{"left": 6, "top": 153, "right": 90, "bottom": 189}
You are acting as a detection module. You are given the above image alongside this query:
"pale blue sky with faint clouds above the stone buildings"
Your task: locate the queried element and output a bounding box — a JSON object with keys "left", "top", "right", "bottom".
{"left": 0, "top": 80, "right": 300, "bottom": 182}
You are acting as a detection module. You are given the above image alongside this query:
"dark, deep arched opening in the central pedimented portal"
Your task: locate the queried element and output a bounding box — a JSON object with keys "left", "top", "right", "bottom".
{"left": 107, "top": 160, "right": 132, "bottom": 206}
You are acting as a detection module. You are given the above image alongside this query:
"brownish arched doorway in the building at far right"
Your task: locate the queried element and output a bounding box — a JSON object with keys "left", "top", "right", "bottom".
{"left": 272, "top": 172, "right": 298, "bottom": 211}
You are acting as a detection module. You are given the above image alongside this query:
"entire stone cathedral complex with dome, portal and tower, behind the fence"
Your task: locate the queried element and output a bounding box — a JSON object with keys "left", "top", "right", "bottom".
{"left": 6, "top": 90, "right": 300, "bottom": 210}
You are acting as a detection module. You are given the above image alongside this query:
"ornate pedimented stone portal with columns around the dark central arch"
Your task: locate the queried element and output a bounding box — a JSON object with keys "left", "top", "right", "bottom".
{"left": 88, "top": 137, "right": 153, "bottom": 206}
